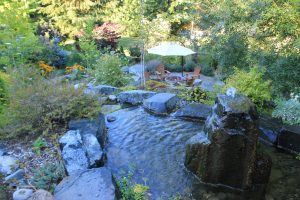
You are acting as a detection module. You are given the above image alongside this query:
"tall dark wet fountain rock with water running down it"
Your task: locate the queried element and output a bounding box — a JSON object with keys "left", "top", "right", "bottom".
{"left": 185, "top": 94, "right": 271, "bottom": 189}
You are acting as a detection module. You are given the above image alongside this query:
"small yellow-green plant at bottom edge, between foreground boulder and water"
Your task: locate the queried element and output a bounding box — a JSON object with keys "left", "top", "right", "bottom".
{"left": 117, "top": 172, "right": 149, "bottom": 200}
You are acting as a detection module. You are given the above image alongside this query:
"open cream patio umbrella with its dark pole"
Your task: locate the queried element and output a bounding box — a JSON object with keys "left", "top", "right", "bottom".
{"left": 147, "top": 42, "right": 196, "bottom": 76}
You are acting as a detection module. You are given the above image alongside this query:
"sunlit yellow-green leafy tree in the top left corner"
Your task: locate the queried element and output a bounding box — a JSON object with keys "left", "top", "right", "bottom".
{"left": 0, "top": 0, "right": 42, "bottom": 68}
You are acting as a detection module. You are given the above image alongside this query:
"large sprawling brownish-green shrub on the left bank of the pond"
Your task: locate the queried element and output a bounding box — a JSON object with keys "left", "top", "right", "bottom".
{"left": 0, "top": 68, "right": 100, "bottom": 138}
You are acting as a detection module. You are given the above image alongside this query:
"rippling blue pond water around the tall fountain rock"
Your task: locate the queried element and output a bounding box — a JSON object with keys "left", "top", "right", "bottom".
{"left": 107, "top": 108, "right": 300, "bottom": 200}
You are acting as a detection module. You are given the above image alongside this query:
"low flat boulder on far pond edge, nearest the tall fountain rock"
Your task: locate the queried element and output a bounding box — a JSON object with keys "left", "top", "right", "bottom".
{"left": 174, "top": 103, "right": 211, "bottom": 120}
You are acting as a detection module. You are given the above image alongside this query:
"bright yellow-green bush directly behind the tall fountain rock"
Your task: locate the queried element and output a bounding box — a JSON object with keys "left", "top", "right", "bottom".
{"left": 223, "top": 66, "right": 271, "bottom": 107}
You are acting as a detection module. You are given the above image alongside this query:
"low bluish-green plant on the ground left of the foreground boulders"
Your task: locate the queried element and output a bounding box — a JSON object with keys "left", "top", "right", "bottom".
{"left": 31, "top": 162, "right": 66, "bottom": 192}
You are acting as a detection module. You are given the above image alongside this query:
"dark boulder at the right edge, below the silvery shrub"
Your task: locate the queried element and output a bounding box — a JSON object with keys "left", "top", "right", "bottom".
{"left": 277, "top": 126, "right": 300, "bottom": 153}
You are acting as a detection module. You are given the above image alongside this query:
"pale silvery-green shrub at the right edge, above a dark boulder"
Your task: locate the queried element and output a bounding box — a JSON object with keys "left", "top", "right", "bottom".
{"left": 272, "top": 96, "right": 300, "bottom": 125}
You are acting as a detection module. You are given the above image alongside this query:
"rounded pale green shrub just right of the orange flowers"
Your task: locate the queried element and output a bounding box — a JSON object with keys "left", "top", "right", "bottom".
{"left": 87, "top": 54, "right": 131, "bottom": 87}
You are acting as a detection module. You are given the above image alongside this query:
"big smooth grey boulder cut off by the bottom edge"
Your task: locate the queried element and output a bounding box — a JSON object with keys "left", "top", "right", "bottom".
{"left": 54, "top": 167, "right": 116, "bottom": 200}
